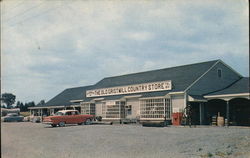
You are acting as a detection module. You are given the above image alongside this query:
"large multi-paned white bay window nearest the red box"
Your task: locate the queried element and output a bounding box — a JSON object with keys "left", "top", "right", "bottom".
{"left": 140, "top": 98, "right": 171, "bottom": 119}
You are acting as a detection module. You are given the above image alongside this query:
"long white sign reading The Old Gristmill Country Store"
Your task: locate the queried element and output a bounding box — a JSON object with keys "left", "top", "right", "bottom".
{"left": 86, "top": 81, "right": 172, "bottom": 97}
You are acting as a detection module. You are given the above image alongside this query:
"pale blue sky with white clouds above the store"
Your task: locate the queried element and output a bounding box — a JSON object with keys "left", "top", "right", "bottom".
{"left": 1, "top": 0, "right": 249, "bottom": 103}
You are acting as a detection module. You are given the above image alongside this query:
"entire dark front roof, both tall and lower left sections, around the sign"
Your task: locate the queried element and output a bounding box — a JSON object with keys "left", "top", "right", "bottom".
{"left": 45, "top": 60, "right": 218, "bottom": 106}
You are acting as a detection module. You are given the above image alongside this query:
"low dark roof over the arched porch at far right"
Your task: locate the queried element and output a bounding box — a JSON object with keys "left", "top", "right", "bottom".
{"left": 206, "top": 77, "right": 250, "bottom": 96}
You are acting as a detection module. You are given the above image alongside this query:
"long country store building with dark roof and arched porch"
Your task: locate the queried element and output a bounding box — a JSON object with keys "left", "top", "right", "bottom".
{"left": 29, "top": 60, "right": 250, "bottom": 125}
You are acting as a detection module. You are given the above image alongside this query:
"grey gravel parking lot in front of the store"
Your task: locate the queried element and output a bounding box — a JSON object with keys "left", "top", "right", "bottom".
{"left": 1, "top": 122, "right": 250, "bottom": 158}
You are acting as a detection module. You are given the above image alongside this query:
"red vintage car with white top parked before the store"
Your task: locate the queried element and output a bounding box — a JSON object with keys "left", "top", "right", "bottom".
{"left": 43, "top": 110, "right": 94, "bottom": 127}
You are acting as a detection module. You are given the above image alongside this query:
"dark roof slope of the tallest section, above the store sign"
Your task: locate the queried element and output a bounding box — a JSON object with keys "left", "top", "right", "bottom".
{"left": 93, "top": 60, "right": 219, "bottom": 91}
